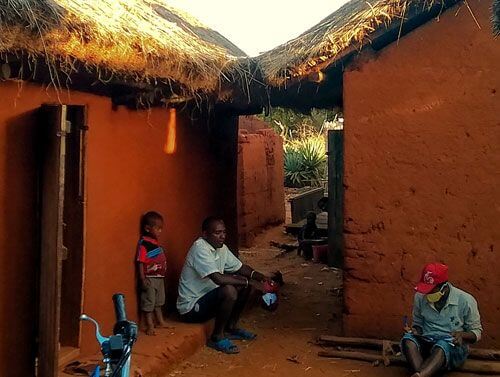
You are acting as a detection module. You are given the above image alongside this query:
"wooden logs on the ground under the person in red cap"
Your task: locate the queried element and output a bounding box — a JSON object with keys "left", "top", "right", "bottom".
{"left": 318, "top": 335, "right": 500, "bottom": 375}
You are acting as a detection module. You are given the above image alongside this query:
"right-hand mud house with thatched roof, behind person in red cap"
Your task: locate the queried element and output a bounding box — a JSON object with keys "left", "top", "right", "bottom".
{"left": 258, "top": 0, "right": 500, "bottom": 347}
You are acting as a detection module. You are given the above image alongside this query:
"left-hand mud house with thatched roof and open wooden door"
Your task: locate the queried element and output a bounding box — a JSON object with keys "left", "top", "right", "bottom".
{"left": 0, "top": 0, "right": 250, "bottom": 377}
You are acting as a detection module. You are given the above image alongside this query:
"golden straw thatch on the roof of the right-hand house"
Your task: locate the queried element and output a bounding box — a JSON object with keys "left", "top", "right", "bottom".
{"left": 257, "top": 0, "right": 442, "bottom": 86}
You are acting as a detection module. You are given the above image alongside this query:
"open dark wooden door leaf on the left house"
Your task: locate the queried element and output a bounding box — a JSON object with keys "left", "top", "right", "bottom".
{"left": 38, "top": 105, "right": 67, "bottom": 377}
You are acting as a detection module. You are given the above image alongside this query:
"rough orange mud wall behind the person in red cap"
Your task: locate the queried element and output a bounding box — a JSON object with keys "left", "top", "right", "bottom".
{"left": 344, "top": 1, "right": 500, "bottom": 347}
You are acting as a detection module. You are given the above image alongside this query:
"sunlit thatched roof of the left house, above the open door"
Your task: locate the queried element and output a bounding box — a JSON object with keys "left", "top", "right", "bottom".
{"left": 0, "top": 0, "right": 245, "bottom": 92}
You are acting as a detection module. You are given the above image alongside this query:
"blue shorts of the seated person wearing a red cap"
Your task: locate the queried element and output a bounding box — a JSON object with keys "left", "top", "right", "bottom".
{"left": 401, "top": 334, "right": 469, "bottom": 370}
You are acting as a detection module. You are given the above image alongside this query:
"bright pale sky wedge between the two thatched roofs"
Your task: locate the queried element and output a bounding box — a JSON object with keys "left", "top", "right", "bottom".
{"left": 168, "top": 0, "right": 346, "bottom": 56}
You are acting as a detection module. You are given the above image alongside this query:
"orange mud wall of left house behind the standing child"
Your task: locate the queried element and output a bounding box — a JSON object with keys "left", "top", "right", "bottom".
{"left": 0, "top": 82, "right": 237, "bottom": 377}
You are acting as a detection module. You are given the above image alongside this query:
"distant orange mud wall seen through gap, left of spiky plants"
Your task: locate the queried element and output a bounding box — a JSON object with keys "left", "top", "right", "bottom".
{"left": 237, "top": 117, "right": 285, "bottom": 247}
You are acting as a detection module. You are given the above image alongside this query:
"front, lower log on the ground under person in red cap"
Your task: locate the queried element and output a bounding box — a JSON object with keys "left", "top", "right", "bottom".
{"left": 318, "top": 351, "right": 500, "bottom": 375}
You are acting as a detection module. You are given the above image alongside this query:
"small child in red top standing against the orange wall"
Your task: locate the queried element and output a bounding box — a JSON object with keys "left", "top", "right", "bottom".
{"left": 137, "top": 211, "right": 167, "bottom": 335}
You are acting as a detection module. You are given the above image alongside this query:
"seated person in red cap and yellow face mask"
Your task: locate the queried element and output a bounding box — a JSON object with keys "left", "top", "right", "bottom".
{"left": 401, "top": 263, "right": 483, "bottom": 377}
